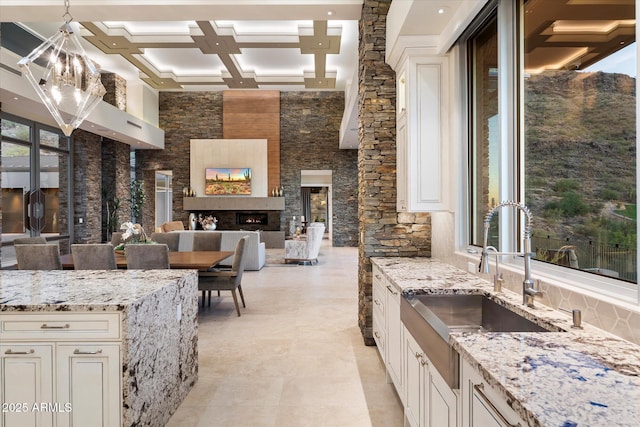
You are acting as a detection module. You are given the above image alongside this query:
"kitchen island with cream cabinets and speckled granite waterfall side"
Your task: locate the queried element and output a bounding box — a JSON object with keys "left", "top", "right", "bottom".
{"left": 0, "top": 270, "right": 198, "bottom": 427}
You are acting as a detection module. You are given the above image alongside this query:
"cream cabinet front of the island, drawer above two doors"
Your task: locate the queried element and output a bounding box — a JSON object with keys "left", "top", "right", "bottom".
{"left": 0, "top": 312, "right": 122, "bottom": 427}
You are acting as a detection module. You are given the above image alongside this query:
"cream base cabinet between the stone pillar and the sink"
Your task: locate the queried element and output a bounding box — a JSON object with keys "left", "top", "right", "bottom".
{"left": 372, "top": 265, "right": 404, "bottom": 400}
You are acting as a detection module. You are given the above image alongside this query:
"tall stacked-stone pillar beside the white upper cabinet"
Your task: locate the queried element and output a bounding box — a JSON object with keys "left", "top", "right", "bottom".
{"left": 358, "top": 0, "right": 431, "bottom": 345}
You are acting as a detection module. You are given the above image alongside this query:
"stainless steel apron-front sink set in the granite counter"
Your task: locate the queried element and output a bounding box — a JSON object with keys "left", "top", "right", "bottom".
{"left": 400, "top": 295, "right": 561, "bottom": 388}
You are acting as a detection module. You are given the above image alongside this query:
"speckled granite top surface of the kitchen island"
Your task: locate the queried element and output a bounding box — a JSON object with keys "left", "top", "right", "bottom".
{"left": 0, "top": 270, "right": 197, "bottom": 312}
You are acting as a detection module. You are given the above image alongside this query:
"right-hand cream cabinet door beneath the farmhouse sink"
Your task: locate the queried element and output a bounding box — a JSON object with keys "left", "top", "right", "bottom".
{"left": 427, "top": 365, "right": 458, "bottom": 427}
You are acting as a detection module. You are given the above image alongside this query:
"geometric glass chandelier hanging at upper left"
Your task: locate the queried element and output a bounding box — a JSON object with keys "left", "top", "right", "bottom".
{"left": 18, "top": 0, "right": 107, "bottom": 136}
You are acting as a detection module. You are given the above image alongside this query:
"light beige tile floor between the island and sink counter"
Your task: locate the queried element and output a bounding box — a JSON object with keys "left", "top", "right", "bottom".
{"left": 167, "top": 242, "right": 403, "bottom": 427}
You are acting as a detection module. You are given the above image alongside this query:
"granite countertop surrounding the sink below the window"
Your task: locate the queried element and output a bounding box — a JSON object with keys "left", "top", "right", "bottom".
{"left": 371, "top": 258, "right": 640, "bottom": 427}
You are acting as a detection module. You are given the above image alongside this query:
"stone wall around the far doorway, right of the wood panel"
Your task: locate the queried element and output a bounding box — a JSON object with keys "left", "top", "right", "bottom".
{"left": 280, "top": 91, "right": 358, "bottom": 246}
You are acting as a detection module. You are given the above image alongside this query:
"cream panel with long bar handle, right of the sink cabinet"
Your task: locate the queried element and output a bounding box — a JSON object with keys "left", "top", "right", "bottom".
{"left": 460, "top": 360, "right": 528, "bottom": 427}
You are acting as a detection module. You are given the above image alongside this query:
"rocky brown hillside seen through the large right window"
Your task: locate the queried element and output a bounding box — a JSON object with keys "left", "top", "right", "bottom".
{"left": 525, "top": 71, "right": 636, "bottom": 244}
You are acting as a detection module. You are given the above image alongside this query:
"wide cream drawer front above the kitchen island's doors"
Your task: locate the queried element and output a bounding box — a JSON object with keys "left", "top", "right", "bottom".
{"left": 0, "top": 312, "right": 121, "bottom": 341}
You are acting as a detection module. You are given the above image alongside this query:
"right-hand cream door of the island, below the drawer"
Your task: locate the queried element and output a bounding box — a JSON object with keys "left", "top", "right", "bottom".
{"left": 56, "top": 344, "right": 122, "bottom": 427}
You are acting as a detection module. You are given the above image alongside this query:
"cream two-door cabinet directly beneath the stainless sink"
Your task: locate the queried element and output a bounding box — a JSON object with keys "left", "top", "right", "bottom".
{"left": 403, "top": 327, "right": 459, "bottom": 427}
